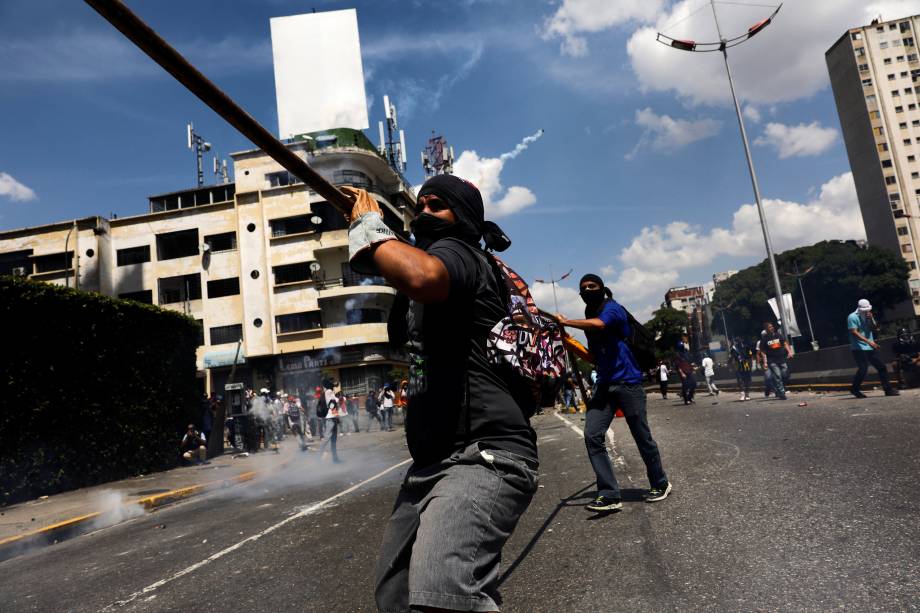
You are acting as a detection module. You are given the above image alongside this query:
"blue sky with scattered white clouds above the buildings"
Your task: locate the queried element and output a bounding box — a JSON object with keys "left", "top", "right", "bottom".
{"left": 0, "top": 0, "right": 920, "bottom": 316}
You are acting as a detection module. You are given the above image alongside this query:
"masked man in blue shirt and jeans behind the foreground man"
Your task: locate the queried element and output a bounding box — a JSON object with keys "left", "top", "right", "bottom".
{"left": 557, "top": 274, "right": 671, "bottom": 512}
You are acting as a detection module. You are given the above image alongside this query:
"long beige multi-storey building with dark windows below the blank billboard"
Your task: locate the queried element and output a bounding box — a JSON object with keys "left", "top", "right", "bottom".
{"left": 0, "top": 129, "right": 415, "bottom": 394}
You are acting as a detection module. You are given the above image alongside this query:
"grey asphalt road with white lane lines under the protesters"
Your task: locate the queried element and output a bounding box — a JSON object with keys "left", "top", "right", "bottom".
{"left": 0, "top": 391, "right": 920, "bottom": 613}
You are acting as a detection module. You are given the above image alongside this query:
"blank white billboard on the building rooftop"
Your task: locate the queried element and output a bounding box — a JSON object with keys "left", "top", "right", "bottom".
{"left": 271, "top": 9, "right": 368, "bottom": 139}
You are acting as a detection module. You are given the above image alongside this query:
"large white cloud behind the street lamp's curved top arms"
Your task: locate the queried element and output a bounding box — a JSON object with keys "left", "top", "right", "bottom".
{"left": 626, "top": 0, "right": 920, "bottom": 104}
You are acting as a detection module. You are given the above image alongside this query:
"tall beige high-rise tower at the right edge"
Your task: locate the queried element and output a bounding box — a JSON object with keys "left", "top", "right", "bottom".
{"left": 825, "top": 15, "right": 920, "bottom": 315}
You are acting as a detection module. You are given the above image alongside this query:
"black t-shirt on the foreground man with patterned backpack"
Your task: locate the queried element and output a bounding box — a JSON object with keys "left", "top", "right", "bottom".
{"left": 406, "top": 238, "right": 537, "bottom": 466}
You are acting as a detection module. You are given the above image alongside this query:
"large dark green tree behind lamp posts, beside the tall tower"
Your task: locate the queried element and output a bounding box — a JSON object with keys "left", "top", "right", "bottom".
{"left": 712, "top": 241, "right": 910, "bottom": 346}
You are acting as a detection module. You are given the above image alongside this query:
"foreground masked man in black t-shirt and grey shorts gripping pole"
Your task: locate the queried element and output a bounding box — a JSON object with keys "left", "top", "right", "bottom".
{"left": 343, "top": 175, "right": 537, "bottom": 613}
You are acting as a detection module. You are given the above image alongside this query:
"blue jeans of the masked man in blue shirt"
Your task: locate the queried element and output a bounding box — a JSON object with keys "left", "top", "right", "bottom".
{"left": 585, "top": 383, "right": 668, "bottom": 500}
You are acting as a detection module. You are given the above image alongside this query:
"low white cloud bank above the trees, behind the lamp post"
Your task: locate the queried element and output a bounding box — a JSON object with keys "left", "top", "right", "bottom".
{"left": 608, "top": 173, "right": 865, "bottom": 321}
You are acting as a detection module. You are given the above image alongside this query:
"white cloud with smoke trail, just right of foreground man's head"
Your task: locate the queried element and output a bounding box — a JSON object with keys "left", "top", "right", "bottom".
{"left": 454, "top": 130, "right": 543, "bottom": 219}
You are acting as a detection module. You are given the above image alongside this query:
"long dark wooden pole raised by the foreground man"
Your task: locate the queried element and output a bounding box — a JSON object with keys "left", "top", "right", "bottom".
{"left": 85, "top": 0, "right": 352, "bottom": 215}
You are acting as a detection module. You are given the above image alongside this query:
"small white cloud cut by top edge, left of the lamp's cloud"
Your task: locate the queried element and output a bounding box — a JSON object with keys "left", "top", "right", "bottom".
{"left": 543, "top": 0, "right": 664, "bottom": 57}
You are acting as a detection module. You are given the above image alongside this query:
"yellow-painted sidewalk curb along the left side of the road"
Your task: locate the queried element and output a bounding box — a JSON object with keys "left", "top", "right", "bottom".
{"left": 0, "top": 460, "right": 291, "bottom": 562}
